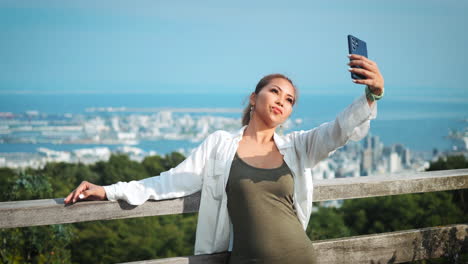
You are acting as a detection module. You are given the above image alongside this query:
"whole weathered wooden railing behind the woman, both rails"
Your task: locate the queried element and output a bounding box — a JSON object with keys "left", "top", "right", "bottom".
{"left": 0, "top": 169, "right": 468, "bottom": 264}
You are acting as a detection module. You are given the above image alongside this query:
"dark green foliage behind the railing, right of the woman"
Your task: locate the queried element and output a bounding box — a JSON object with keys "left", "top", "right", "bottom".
{"left": 307, "top": 155, "right": 468, "bottom": 263}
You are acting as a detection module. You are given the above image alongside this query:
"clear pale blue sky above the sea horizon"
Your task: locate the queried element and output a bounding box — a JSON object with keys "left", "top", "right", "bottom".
{"left": 0, "top": 0, "right": 468, "bottom": 98}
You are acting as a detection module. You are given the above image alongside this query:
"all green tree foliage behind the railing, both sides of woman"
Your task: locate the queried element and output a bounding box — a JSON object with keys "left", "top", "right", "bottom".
{"left": 0, "top": 152, "right": 468, "bottom": 263}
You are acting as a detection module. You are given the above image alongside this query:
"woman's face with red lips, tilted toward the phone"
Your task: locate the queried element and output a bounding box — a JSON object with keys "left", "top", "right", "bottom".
{"left": 250, "top": 78, "right": 296, "bottom": 127}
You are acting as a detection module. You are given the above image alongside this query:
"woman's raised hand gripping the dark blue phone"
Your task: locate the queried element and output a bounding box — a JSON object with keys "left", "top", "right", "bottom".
{"left": 348, "top": 54, "right": 384, "bottom": 95}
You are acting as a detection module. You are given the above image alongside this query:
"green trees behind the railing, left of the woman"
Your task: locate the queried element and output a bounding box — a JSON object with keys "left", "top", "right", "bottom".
{"left": 0, "top": 153, "right": 197, "bottom": 263}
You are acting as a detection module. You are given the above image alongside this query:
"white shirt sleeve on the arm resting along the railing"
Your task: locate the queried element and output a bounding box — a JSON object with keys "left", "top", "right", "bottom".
{"left": 103, "top": 133, "right": 215, "bottom": 205}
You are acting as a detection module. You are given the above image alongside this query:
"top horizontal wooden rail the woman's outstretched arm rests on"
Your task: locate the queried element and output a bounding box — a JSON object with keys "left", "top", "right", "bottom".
{"left": 0, "top": 169, "right": 468, "bottom": 228}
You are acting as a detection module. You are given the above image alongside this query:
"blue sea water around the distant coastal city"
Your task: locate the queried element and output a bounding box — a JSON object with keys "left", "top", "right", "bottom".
{"left": 0, "top": 93, "right": 468, "bottom": 158}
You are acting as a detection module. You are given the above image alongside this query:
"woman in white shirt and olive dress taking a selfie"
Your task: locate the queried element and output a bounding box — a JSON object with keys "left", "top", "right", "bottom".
{"left": 65, "top": 55, "right": 384, "bottom": 263}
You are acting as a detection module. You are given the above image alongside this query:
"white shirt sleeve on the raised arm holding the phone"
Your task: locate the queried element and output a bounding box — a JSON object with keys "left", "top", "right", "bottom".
{"left": 293, "top": 94, "right": 377, "bottom": 165}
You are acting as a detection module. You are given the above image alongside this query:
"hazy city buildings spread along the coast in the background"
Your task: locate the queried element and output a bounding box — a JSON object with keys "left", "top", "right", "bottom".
{"left": 0, "top": 109, "right": 428, "bottom": 175}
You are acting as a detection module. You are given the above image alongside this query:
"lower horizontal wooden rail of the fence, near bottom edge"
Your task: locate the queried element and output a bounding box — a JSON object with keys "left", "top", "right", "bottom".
{"left": 119, "top": 224, "right": 468, "bottom": 264}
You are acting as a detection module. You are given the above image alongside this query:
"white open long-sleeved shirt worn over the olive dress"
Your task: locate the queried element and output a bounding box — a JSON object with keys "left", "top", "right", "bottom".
{"left": 104, "top": 95, "right": 377, "bottom": 255}
